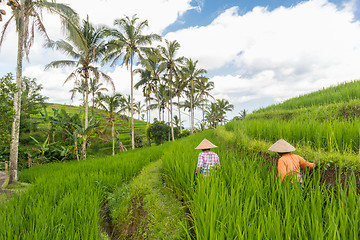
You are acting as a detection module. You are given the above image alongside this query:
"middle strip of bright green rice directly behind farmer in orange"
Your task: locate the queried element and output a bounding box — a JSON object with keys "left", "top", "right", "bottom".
{"left": 227, "top": 119, "right": 360, "bottom": 153}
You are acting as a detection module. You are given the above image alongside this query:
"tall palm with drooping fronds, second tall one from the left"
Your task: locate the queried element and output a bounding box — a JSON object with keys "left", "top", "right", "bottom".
{"left": 45, "top": 18, "right": 114, "bottom": 159}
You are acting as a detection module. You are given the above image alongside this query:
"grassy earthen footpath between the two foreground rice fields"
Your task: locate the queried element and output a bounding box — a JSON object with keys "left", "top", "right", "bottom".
{"left": 101, "top": 160, "right": 188, "bottom": 239}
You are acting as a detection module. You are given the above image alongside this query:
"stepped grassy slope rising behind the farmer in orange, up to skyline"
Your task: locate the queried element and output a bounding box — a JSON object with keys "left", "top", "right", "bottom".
{"left": 231, "top": 81, "right": 360, "bottom": 167}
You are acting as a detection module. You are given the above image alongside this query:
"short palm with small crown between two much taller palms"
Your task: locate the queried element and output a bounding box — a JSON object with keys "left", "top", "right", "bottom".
{"left": 98, "top": 93, "right": 123, "bottom": 156}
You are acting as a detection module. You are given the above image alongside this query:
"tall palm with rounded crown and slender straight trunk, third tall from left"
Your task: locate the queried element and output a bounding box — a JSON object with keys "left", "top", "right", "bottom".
{"left": 104, "top": 15, "right": 161, "bottom": 149}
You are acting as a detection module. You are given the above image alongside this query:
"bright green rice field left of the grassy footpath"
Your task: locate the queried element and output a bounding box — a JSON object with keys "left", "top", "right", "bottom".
{"left": 0, "top": 148, "right": 161, "bottom": 239}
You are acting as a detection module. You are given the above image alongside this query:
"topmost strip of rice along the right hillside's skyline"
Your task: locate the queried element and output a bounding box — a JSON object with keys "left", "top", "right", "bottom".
{"left": 257, "top": 81, "right": 360, "bottom": 112}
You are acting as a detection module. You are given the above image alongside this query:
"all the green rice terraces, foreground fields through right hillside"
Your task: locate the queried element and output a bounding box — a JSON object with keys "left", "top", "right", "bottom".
{"left": 0, "top": 82, "right": 360, "bottom": 239}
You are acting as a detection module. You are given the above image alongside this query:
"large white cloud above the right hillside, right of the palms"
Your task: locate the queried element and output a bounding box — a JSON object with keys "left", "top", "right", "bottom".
{"left": 166, "top": 0, "right": 360, "bottom": 113}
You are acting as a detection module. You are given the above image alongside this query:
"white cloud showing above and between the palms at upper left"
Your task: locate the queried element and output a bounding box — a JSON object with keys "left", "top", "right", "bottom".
{"left": 0, "top": 0, "right": 198, "bottom": 104}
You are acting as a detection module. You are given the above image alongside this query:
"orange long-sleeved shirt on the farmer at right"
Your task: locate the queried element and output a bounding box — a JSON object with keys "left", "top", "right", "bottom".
{"left": 278, "top": 153, "right": 314, "bottom": 181}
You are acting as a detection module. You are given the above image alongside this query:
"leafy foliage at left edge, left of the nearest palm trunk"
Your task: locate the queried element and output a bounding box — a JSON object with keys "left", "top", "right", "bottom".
{"left": 0, "top": 73, "right": 16, "bottom": 146}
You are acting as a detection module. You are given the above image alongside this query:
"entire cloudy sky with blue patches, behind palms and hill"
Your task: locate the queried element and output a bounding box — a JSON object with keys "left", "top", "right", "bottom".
{"left": 0, "top": 0, "right": 360, "bottom": 126}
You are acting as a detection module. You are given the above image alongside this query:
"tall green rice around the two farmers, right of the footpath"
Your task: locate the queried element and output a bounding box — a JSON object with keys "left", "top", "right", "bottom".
{"left": 163, "top": 130, "right": 360, "bottom": 239}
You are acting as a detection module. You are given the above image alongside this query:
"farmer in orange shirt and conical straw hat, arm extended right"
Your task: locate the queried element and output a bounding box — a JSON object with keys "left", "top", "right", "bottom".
{"left": 269, "top": 139, "right": 316, "bottom": 187}
